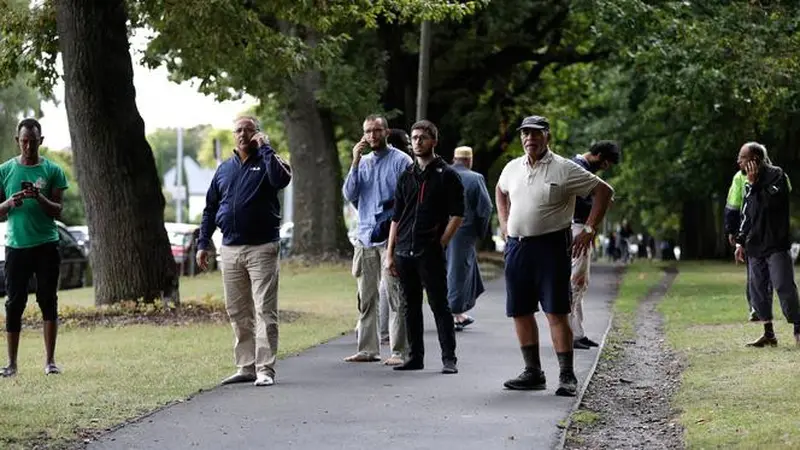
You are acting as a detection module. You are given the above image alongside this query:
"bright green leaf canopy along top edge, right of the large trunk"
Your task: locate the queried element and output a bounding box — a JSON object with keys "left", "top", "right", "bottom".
{"left": 129, "top": 0, "right": 488, "bottom": 99}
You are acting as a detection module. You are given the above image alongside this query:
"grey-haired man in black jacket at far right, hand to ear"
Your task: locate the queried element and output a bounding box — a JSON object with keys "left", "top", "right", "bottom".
{"left": 735, "top": 142, "right": 800, "bottom": 347}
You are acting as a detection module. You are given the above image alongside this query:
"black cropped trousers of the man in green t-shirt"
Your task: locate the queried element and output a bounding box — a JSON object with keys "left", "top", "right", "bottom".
{"left": 5, "top": 242, "right": 61, "bottom": 333}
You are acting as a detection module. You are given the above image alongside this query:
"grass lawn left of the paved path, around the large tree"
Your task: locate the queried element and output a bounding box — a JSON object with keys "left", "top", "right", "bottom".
{"left": 0, "top": 264, "right": 357, "bottom": 449}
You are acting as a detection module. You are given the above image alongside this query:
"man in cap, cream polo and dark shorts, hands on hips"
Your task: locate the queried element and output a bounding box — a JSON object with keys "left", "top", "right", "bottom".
{"left": 495, "top": 116, "right": 614, "bottom": 396}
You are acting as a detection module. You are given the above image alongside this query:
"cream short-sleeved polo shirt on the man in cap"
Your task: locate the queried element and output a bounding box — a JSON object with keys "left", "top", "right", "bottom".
{"left": 497, "top": 151, "right": 602, "bottom": 237}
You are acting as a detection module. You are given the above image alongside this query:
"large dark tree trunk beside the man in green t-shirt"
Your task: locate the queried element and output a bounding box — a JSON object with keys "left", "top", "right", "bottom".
{"left": 56, "top": 0, "right": 177, "bottom": 305}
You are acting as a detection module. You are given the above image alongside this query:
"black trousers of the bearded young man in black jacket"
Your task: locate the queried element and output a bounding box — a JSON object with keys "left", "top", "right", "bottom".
{"left": 395, "top": 248, "right": 456, "bottom": 362}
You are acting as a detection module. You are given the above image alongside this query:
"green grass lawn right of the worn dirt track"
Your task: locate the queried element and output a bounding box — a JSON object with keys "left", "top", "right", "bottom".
{"left": 660, "top": 262, "right": 800, "bottom": 449}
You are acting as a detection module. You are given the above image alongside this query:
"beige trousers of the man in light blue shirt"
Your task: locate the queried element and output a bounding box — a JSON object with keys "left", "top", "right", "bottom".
{"left": 353, "top": 242, "right": 407, "bottom": 358}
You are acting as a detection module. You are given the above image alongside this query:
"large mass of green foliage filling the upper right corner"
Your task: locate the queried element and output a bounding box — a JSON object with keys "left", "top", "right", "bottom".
{"left": 520, "top": 0, "right": 800, "bottom": 243}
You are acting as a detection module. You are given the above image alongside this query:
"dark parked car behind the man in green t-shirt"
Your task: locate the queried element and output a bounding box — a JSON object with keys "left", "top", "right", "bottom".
{"left": 0, "top": 222, "right": 89, "bottom": 297}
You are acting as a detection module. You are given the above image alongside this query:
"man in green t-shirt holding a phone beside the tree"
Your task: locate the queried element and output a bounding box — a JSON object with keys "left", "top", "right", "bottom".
{"left": 0, "top": 119, "right": 67, "bottom": 377}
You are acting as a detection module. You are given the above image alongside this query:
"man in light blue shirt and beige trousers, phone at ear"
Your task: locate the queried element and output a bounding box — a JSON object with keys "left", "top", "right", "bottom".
{"left": 342, "top": 115, "right": 412, "bottom": 365}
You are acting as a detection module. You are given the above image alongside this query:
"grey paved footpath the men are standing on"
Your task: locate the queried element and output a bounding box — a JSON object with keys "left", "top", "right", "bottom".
{"left": 88, "top": 266, "right": 616, "bottom": 450}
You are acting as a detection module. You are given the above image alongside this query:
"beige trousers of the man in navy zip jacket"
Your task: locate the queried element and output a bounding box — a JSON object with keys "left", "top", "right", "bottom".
{"left": 221, "top": 242, "right": 280, "bottom": 377}
